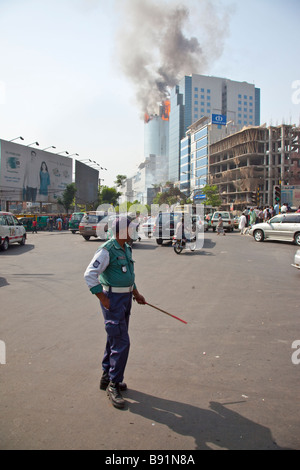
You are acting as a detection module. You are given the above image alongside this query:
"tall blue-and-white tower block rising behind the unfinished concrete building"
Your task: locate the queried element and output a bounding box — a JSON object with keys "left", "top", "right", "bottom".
{"left": 168, "top": 74, "right": 260, "bottom": 182}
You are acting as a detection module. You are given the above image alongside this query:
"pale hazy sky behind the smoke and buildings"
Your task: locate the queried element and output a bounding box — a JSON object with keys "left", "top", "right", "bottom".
{"left": 0, "top": 0, "right": 300, "bottom": 185}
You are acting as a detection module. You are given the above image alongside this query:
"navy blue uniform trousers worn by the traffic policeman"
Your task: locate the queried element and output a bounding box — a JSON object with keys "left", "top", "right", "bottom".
{"left": 101, "top": 292, "right": 132, "bottom": 383}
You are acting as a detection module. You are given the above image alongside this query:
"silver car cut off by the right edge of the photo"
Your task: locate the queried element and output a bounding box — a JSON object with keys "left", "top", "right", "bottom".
{"left": 249, "top": 213, "right": 300, "bottom": 246}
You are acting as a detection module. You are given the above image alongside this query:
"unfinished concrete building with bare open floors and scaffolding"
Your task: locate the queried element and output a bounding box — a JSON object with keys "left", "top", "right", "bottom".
{"left": 209, "top": 124, "right": 300, "bottom": 210}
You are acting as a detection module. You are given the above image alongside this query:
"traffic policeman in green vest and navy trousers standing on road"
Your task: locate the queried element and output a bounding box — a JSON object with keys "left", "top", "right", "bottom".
{"left": 84, "top": 217, "right": 146, "bottom": 408}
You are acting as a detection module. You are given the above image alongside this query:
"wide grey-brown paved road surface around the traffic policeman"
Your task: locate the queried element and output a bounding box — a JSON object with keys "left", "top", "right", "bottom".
{"left": 0, "top": 229, "right": 300, "bottom": 450}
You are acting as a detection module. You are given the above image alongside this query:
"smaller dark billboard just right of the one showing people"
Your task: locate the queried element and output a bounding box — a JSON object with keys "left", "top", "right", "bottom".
{"left": 75, "top": 160, "right": 99, "bottom": 204}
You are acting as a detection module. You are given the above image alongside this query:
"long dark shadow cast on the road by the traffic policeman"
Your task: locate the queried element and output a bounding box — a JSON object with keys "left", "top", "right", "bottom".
{"left": 124, "top": 390, "right": 280, "bottom": 450}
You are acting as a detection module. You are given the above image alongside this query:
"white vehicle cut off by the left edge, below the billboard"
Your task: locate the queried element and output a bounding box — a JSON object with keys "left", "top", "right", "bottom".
{"left": 0, "top": 212, "right": 26, "bottom": 251}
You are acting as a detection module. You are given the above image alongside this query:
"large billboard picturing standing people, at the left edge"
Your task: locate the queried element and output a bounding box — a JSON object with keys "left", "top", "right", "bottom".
{"left": 0, "top": 140, "right": 72, "bottom": 203}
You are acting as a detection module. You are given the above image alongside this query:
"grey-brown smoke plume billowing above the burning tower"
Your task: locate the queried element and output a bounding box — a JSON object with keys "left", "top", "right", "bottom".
{"left": 117, "top": 0, "right": 232, "bottom": 116}
